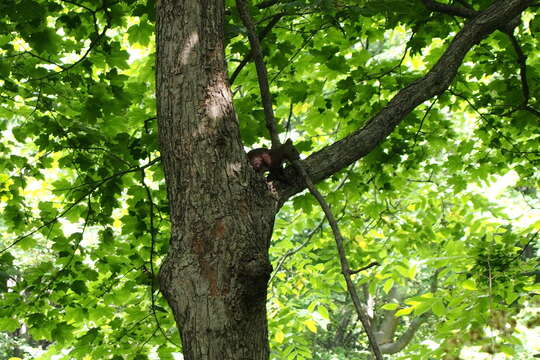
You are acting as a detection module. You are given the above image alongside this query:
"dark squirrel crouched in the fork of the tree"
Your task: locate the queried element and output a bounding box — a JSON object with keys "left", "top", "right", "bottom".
{"left": 247, "top": 139, "right": 299, "bottom": 182}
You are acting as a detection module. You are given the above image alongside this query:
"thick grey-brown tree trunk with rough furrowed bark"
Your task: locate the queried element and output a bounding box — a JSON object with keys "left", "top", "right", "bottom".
{"left": 156, "top": 0, "right": 277, "bottom": 360}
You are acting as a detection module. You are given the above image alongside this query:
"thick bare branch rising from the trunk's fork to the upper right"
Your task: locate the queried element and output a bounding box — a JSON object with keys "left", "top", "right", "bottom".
{"left": 280, "top": 0, "right": 532, "bottom": 201}
